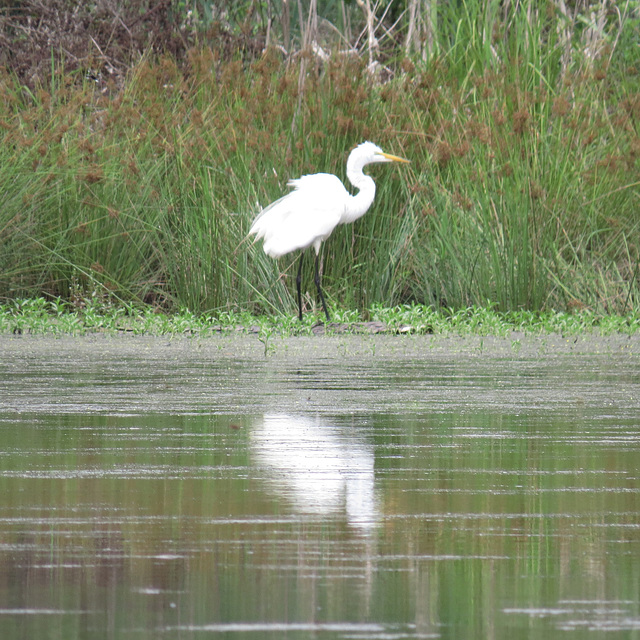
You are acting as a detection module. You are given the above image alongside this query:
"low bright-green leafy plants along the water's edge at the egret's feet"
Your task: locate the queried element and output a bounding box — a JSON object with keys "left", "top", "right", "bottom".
{"left": 0, "top": 298, "right": 640, "bottom": 338}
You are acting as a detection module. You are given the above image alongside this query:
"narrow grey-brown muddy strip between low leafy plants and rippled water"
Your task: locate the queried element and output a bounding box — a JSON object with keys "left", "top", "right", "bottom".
{"left": 0, "top": 332, "right": 640, "bottom": 360}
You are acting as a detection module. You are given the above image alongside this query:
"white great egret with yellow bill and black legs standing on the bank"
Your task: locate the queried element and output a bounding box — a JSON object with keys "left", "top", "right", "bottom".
{"left": 249, "top": 142, "right": 409, "bottom": 321}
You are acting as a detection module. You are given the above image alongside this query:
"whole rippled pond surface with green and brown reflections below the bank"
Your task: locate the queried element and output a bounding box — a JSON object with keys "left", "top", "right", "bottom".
{"left": 0, "top": 336, "right": 640, "bottom": 640}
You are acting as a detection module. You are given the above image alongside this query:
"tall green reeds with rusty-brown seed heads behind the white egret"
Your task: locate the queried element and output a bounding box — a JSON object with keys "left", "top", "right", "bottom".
{"left": 0, "top": 3, "right": 640, "bottom": 318}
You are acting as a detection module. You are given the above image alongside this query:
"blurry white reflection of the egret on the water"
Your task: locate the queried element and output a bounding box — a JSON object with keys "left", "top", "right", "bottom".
{"left": 251, "top": 414, "right": 379, "bottom": 531}
